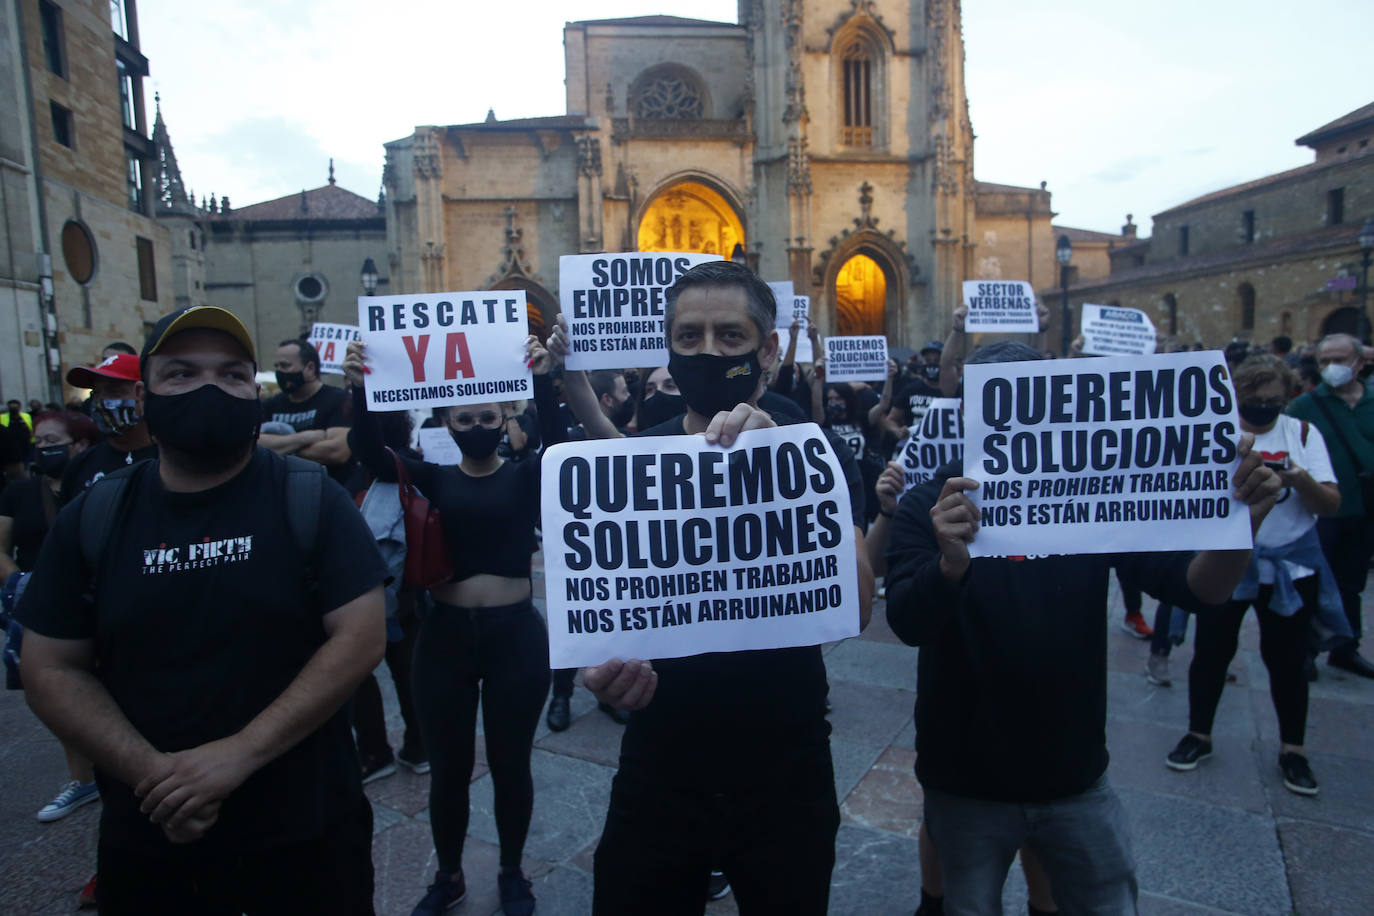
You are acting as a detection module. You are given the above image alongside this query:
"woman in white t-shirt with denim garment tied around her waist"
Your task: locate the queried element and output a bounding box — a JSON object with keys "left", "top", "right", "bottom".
{"left": 1165, "top": 354, "right": 1348, "bottom": 795}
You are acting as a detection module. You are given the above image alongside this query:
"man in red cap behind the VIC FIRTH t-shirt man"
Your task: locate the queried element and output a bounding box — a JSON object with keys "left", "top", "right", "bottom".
{"left": 59, "top": 347, "right": 158, "bottom": 504}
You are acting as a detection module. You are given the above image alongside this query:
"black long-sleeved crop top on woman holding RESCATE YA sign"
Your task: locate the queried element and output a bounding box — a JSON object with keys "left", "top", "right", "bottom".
{"left": 348, "top": 375, "right": 567, "bottom": 582}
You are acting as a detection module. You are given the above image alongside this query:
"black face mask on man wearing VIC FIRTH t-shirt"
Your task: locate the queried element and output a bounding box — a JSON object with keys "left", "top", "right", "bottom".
{"left": 143, "top": 385, "right": 262, "bottom": 474}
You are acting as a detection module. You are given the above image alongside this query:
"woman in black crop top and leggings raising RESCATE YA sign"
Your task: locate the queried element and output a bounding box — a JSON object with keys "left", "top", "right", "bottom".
{"left": 344, "top": 336, "right": 567, "bottom": 916}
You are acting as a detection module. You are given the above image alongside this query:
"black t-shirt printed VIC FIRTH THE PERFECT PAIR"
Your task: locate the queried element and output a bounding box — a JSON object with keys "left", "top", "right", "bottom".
{"left": 18, "top": 448, "right": 387, "bottom": 846}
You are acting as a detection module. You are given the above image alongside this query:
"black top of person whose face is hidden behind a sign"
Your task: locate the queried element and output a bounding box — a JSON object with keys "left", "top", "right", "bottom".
{"left": 886, "top": 464, "right": 1205, "bottom": 803}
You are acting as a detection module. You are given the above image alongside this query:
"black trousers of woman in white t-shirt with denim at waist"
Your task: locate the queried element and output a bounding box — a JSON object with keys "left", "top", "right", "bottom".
{"left": 1189, "top": 585, "right": 1318, "bottom": 744}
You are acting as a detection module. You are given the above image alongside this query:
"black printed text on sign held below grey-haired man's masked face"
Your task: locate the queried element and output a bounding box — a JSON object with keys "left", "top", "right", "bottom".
{"left": 559, "top": 439, "right": 849, "bottom": 633}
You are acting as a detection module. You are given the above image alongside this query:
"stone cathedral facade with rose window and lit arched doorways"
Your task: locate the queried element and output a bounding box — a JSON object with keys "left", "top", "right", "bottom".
{"left": 383, "top": 0, "right": 1055, "bottom": 346}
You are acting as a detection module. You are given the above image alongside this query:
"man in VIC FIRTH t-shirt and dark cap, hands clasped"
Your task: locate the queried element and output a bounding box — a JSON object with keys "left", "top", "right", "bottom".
{"left": 18, "top": 306, "right": 386, "bottom": 915}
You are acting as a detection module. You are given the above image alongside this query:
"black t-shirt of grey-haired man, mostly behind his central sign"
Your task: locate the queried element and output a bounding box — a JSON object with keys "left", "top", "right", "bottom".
{"left": 620, "top": 415, "right": 863, "bottom": 790}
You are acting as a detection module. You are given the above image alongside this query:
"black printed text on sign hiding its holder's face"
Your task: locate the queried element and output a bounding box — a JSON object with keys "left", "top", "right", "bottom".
{"left": 982, "top": 365, "right": 1239, "bottom": 526}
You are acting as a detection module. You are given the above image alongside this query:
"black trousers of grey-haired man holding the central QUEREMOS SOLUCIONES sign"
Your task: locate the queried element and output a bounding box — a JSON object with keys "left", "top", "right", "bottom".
{"left": 592, "top": 747, "right": 840, "bottom": 916}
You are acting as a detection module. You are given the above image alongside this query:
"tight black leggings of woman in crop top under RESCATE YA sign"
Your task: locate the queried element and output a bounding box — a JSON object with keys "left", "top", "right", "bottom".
{"left": 414, "top": 600, "right": 548, "bottom": 872}
